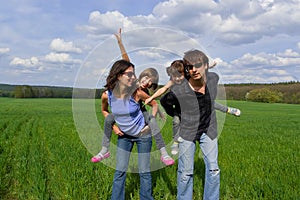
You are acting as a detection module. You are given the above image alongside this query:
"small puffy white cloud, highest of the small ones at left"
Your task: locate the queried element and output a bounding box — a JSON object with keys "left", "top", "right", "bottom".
{"left": 50, "top": 38, "right": 82, "bottom": 53}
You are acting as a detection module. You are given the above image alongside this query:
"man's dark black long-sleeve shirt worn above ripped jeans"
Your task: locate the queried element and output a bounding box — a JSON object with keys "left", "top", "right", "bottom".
{"left": 160, "top": 72, "right": 219, "bottom": 141}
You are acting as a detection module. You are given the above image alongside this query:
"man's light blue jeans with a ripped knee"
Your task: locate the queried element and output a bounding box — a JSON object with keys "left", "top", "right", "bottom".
{"left": 177, "top": 133, "right": 220, "bottom": 200}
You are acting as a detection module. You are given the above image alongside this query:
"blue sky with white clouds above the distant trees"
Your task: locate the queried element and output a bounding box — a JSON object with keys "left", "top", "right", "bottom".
{"left": 0, "top": 0, "right": 300, "bottom": 88}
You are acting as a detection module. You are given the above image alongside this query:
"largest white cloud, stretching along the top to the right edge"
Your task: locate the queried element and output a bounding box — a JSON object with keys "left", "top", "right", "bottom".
{"left": 80, "top": 0, "right": 300, "bottom": 45}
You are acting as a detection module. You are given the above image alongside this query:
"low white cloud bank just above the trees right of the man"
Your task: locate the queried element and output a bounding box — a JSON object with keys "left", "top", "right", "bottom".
{"left": 218, "top": 51, "right": 300, "bottom": 83}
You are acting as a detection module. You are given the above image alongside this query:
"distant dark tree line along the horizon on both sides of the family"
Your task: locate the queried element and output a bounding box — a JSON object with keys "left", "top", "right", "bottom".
{"left": 0, "top": 82, "right": 300, "bottom": 104}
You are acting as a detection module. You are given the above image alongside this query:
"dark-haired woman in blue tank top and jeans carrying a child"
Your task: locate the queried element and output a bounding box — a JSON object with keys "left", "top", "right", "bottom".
{"left": 102, "top": 60, "right": 158, "bottom": 200}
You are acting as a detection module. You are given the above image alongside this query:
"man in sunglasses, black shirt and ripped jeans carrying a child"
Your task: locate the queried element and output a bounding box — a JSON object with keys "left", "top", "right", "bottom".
{"left": 161, "top": 50, "right": 220, "bottom": 200}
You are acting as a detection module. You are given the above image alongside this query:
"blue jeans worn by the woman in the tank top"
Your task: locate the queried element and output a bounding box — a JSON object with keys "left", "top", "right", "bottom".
{"left": 111, "top": 132, "right": 153, "bottom": 200}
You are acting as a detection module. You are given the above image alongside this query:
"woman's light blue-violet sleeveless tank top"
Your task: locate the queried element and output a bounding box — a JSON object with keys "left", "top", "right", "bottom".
{"left": 107, "top": 90, "right": 145, "bottom": 136}
